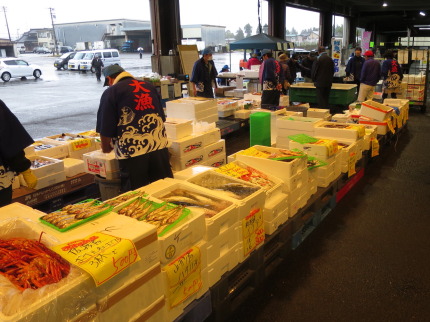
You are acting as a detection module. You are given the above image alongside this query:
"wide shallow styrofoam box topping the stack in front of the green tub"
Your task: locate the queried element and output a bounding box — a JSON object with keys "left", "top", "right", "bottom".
{"left": 315, "top": 122, "right": 365, "bottom": 140}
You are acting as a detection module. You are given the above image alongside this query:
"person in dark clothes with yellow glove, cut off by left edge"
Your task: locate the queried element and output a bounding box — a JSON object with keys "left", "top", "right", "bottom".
{"left": 0, "top": 100, "right": 37, "bottom": 207}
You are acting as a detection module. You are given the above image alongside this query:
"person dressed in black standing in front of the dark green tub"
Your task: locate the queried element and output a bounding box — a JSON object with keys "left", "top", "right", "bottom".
{"left": 312, "top": 46, "right": 334, "bottom": 108}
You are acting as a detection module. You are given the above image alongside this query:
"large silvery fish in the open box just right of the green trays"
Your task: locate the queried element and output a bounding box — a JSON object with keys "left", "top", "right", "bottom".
{"left": 158, "top": 188, "right": 232, "bottom": 218}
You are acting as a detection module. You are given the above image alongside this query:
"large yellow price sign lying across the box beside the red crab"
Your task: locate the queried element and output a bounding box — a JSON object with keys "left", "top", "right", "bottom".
{"left": 52, "top": 233, "right": 140, "bottom": 286}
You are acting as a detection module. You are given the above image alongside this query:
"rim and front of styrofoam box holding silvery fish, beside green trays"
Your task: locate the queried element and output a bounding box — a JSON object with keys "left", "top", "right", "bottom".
{"left": 144, "top": 178, "right": 239, "bottom": 240}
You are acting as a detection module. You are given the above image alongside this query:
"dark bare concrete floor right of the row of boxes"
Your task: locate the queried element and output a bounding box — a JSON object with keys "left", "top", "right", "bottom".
{"left": 227, "top": 110, "right": 430, "bottom": 322}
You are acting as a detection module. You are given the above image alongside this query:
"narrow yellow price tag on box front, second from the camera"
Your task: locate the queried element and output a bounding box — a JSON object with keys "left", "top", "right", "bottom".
{"left": 242, "top": 209, "right": 265, "bottom": 256}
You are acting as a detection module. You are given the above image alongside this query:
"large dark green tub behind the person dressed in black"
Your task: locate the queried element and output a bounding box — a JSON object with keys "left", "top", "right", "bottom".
{"left": 289, "top": 83, "right": 357, "bottom": 105}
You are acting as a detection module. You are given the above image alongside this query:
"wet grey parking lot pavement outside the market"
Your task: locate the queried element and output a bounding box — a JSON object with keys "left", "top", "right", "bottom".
{"left": 0, "top": 53, "right": 243, "bottom": 139}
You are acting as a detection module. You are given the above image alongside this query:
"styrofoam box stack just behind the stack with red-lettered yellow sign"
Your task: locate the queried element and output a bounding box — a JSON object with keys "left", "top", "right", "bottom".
{"left": 236, "top": 145, "right": 311, "bottom": 217}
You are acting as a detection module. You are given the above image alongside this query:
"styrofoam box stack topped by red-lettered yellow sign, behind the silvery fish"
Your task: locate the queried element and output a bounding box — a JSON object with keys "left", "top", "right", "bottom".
{"left": 217, "top": 160, "right": 289, "bottom": 235}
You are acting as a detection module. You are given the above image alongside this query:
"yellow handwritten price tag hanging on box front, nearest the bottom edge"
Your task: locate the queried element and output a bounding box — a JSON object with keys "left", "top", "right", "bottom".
{"left": 163, "top": 246, "right": 203, "bottom": 308}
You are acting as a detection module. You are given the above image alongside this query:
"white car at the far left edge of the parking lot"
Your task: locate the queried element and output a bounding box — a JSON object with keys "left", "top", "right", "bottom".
{"left": 0, "top": 58, "right": 42, "bottom": 82}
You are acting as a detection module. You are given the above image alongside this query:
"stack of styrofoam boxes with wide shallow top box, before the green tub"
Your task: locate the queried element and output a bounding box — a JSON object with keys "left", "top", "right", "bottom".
{"left": 315, "top": 122, "right": 365, "bottom": 172}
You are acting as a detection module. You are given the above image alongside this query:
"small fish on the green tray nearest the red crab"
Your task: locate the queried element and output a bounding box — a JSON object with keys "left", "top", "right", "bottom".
{"left": 40, "top": 200, "right": 108, "bottom": 229}
